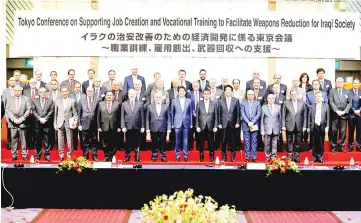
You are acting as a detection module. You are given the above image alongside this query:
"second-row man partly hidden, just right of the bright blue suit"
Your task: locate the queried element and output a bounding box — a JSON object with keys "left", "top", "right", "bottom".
{"left": 187, "top": 81, "right": 203, "bottom": 150}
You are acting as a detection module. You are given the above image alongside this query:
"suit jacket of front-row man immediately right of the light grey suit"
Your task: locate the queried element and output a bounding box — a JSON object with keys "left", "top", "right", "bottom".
{"left": 78, "top": 97, "right": 100, "bottom": 131}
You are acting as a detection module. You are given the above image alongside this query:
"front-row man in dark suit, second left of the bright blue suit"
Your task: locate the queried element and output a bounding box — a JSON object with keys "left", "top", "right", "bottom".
{"left": 120, "top": 89, "right": 145, "bottom": 162}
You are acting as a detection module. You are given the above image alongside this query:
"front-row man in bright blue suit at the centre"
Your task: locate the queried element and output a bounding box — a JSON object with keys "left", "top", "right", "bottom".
{"left": 171, "top": 86, "right": 193, "bottom": 162}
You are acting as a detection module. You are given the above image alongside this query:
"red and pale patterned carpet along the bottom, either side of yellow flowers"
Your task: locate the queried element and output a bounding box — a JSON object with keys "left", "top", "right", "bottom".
{"left": 1, "top": 209, "right": 361, "bottom": 223}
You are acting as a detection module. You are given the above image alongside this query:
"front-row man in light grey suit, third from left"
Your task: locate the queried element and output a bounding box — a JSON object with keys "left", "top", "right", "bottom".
{"left": 54, "top": 87, "right": 78, "bottom": 161}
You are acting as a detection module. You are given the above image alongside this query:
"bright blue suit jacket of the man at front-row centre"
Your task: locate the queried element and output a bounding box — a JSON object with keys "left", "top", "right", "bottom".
{"left": 171, "top": 98, "right": 193, "bottom": 129}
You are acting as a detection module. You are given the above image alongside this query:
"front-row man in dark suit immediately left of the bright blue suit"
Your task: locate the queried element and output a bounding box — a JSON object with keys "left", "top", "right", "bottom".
{"left": 145, "top": 93, "right": 171, "bottom": 162}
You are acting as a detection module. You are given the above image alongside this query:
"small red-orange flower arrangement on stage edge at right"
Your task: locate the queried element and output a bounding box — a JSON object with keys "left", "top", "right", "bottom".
{"left": 266, "top": 156, "right": 300, "bottom": 177}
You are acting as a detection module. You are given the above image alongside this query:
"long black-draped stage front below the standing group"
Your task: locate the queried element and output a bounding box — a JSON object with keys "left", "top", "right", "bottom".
{"left": 2, "top": 163, "right": 361, "bottom": 210}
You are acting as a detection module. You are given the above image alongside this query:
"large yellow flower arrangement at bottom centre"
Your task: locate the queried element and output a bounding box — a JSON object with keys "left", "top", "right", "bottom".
{"left": 141, "top": 189, "right": 238, "bottom": 223}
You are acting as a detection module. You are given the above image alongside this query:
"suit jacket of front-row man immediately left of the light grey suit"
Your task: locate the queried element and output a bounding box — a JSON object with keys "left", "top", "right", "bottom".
{"left": 32, "top": 98, "right": 55, "bottom": 129}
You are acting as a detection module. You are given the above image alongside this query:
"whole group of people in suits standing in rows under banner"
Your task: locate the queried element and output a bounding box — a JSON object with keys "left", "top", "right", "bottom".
{"left": 2, "top": 68, "right": 361, "bottom": 162}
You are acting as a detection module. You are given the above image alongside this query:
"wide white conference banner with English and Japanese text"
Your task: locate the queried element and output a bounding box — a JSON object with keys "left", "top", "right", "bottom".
{"left": 14, "top": 9, "right": 360, "bottom": 59}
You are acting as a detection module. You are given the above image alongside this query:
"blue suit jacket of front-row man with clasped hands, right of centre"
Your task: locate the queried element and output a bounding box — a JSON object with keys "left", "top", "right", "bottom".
{"left": 240, "top": 100, "right": 262, "bottom": 131}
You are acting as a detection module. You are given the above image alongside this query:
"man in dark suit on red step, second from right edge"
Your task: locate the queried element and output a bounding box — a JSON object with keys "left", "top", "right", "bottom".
{"left": 328, "top": 77, "right": 352, "bottom": 152}
